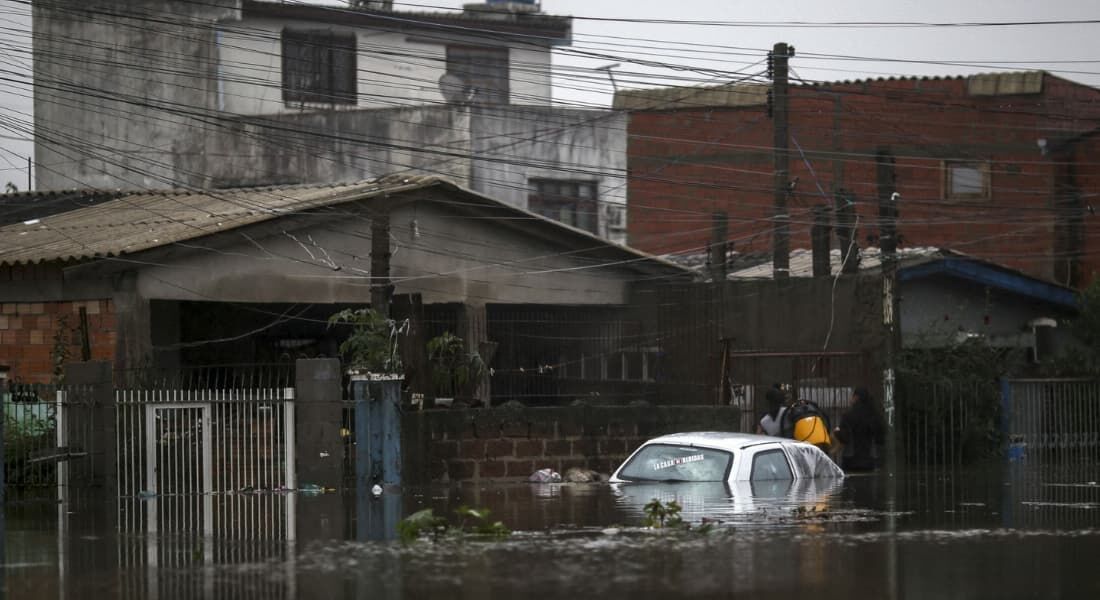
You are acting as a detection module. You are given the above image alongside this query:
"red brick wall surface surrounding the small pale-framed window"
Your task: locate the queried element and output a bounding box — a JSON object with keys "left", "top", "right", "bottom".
{"left": 628, "top": 76, "right": 1100, "bottom": 284}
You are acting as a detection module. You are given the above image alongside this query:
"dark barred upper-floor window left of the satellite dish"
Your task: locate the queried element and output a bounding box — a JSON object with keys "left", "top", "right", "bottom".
{"left": 283, "top": 30, "right": 356, "bottom": 105}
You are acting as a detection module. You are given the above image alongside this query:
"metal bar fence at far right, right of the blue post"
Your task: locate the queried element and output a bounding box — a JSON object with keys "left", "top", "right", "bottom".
{"left": 1002, "top": 379, "right": 1100, "bottom": 461}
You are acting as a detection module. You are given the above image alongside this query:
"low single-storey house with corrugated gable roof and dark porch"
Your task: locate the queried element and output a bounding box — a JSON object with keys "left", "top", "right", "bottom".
{"left": 0, "top": 177, "right": 691, "bottom": 401}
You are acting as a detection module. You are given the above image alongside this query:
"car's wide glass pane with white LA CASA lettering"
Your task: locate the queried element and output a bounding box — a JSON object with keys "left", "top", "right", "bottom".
{"left": 618, "top": 444, "right": 734, "bottom": 481}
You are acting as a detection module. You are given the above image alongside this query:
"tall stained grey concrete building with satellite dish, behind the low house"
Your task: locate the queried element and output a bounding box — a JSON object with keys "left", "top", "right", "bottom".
{"left": 34, "top": 0, "right": 626, "bottom": 242}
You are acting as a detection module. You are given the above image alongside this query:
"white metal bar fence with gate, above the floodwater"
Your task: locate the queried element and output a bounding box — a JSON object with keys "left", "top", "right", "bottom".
{"left": 116, "top": 388, "right": 296, "bottom": 539}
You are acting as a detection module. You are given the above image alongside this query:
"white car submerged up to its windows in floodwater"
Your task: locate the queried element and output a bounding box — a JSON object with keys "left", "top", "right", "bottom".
{"left": 611, "top": 432, "right": 844, "bottom": 483}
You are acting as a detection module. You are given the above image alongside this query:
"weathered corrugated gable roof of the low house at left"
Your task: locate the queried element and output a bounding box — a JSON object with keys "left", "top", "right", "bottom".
{"left": 0, "top": 175, "right": 692, "bottom": 276}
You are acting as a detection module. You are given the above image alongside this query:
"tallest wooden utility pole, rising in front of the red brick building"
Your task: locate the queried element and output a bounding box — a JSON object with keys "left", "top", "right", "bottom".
{"left": 768, "top": 42, "right": 794, "bottom": 280}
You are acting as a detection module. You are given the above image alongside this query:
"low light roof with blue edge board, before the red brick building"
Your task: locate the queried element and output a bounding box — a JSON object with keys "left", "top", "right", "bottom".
{"left": 728, "top": 248, "right": 1078, "bottom": 309}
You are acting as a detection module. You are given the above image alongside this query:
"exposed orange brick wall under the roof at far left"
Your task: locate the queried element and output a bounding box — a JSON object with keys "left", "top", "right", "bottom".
{"left": 0, "top": 299, "right": 117, "bottom": 383}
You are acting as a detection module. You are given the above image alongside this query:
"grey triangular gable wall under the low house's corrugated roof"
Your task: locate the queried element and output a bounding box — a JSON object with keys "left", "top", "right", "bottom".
{"left": 129, "top": 191, "right": 637, "bottom": 305}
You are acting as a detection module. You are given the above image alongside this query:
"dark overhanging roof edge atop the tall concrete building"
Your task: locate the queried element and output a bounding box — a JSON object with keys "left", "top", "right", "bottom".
{"left": 241, "top": 0, "right": 573, "bottom": 44}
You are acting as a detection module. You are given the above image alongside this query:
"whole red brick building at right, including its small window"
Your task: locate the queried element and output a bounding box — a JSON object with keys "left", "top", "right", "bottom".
{"left": 615, "top": 72, "right": 1100, "bottom": 286}
